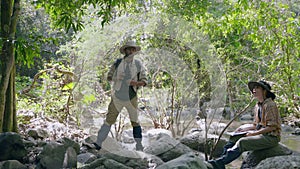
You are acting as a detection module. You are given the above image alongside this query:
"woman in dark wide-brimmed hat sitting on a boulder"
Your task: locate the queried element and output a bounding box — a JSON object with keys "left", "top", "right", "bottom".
{"left": 208, "top": 81, "right": 281, "bottom": 169}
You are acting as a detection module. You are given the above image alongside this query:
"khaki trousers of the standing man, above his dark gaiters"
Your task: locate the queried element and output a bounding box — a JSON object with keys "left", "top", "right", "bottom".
{"left": 105, "top": 95, "right": 140, "bottom": 127}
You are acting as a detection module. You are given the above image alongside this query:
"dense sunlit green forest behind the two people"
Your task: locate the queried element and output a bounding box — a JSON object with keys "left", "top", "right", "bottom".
{"left": 0, "top": 0, "right": 300, "bottom": 135}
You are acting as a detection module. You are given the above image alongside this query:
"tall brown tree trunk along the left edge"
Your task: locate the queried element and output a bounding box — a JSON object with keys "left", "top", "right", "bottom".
{"left": 0, "top": 0, "right": 20, "bottom": 133}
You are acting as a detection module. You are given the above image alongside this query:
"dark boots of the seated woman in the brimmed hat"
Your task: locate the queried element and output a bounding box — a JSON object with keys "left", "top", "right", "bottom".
{"left": 208, "top": 147, "right": 242, "bottom": 169}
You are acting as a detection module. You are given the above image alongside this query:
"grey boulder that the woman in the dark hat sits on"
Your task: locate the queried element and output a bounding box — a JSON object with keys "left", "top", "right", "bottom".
{"left": 241, "top": 143, "right": 293, "bottom": 169}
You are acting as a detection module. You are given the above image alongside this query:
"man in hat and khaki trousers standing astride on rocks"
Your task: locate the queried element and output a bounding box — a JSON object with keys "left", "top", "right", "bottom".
{"left": 93, "top": 41, "right": 147, "bottom": 151}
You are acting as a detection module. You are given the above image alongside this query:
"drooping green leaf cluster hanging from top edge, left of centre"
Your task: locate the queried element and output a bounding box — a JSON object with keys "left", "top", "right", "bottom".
{"left": 34, "top": 0, "right": 135, "bottom": 32}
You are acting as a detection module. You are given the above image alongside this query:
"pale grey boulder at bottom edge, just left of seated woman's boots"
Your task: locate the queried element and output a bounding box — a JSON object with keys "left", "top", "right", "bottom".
{"left": 156, "top": 153, "right": 207, "bottom": 169}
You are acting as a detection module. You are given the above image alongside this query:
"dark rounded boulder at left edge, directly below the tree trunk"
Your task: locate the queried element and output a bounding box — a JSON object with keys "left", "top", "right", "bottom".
{"left": 0, "top": 132, "right": 27, "bottom": 162}
